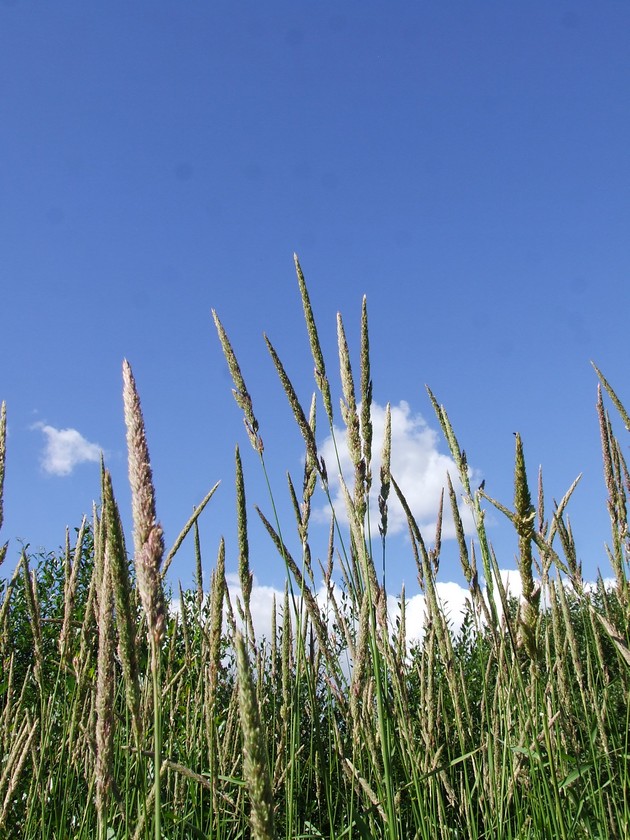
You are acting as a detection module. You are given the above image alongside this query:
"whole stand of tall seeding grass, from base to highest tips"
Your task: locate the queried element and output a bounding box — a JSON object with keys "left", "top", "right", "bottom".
{"left": 0, "top": 261, "right": 630, "bottom": 840}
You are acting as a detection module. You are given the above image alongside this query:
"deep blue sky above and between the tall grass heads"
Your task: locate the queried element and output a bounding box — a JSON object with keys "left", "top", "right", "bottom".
{"left": 0, "top": 0, "right": 630, "bottom": 604}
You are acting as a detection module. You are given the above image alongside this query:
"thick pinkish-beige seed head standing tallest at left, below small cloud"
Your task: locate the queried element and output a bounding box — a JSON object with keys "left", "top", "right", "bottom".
{"left": 123, "top": 360, "right": 165, "bottom": 641}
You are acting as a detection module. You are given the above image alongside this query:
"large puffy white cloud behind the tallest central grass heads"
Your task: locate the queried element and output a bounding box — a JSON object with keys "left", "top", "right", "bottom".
{"left": 318, "top": 401, "right": 480, "bottom": 539}
